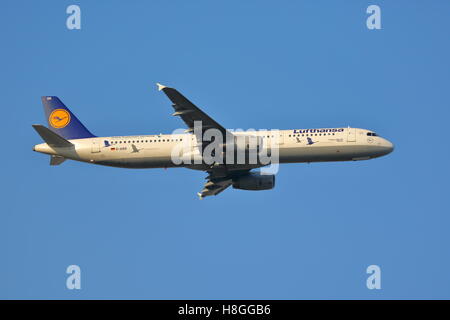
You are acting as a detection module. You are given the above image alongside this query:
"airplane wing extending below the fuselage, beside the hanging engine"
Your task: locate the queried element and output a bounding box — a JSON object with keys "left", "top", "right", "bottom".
{"left": 197, "top": 167, "right": 249, "bottom": 200}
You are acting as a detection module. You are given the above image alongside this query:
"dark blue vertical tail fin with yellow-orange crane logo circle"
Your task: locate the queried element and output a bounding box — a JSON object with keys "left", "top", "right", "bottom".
{"left": 41, "top": 96, "right": 95, "bottom": 139}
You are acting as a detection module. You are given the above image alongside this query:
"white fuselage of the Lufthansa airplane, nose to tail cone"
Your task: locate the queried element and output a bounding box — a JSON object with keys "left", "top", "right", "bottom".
{"left": 33, "top": 128, "right": 393, "bottom": 170}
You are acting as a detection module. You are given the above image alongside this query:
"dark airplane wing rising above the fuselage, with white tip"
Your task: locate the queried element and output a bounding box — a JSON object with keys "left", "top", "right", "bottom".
{"left": 157, "top": 83, "right": 231, "bottom": 137}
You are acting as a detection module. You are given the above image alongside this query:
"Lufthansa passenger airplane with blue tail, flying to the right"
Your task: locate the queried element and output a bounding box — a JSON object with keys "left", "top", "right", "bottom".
{"left": 32, "top": 83, "right": 394, "bottom": 199}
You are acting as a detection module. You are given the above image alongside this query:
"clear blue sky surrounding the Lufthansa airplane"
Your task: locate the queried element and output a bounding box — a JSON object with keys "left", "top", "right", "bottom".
{"left": 0, "top": 0, "right": 450, "bottom": 299}
